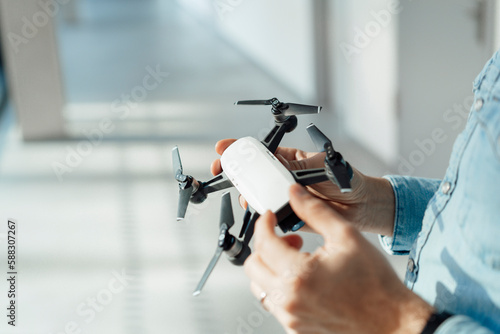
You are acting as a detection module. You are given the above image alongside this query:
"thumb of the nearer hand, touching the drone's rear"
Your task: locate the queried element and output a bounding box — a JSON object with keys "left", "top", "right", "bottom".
{"left": 290, "top": 183, "right": 359, "bottom": 242}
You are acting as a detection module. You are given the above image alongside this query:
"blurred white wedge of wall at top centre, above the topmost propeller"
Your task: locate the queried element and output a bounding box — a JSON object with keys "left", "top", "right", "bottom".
{"left": 217, "top": 0, "right": 315, "bottom": 102}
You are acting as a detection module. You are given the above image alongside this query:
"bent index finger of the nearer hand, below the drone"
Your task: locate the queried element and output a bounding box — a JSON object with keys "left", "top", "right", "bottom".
{"left": 254, "top": 211, "right": 302, "bottom": 274}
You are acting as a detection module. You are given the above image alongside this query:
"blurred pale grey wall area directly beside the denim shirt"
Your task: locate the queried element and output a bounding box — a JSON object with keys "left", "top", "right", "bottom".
{"left": 396, "top": 0, "right": 493, "bottom": 178}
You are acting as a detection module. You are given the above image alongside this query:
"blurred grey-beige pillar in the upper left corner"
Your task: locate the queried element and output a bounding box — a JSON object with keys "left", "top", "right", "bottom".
{"left": 0, "top": 0, "right": 66, "bottom": 140}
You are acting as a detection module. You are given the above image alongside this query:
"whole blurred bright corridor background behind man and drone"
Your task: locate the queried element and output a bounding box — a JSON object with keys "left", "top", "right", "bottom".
{"left": 0, "top": 0, "right": 499, "bottom": 334}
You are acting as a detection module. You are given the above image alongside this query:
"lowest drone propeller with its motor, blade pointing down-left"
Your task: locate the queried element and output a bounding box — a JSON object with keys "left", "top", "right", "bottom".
{"left": 193, "top": 192, "right": 250, "bottom": 296}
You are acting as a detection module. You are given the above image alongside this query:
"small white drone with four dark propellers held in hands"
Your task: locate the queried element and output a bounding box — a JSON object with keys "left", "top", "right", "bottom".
{"left": 172, "top": 98, "right": 353, "bottom": 296}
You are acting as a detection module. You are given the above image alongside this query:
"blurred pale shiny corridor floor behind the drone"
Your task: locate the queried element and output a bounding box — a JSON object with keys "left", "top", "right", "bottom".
{"left": 0, "top": 0, "right": 405, "bottom": 334}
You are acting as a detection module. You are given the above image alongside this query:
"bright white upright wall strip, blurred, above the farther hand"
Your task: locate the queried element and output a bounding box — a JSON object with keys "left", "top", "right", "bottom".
{"left": 330, "top": 0, "right": 399, "bottom": 164}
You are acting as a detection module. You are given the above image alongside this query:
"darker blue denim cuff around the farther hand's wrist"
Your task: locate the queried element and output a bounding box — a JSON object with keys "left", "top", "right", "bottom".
{"left": 379, "top": 175, "right": 441, "bottom": 255}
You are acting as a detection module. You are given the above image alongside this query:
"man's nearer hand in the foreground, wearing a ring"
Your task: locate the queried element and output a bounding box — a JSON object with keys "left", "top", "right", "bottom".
{"left": 245, "top": 185, "right": 433, "bottom": 334}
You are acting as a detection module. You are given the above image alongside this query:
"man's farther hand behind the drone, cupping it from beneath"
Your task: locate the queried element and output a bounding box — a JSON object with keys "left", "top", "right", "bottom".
{"left": 210, "top": 139, "right": 394, "bottom": 236}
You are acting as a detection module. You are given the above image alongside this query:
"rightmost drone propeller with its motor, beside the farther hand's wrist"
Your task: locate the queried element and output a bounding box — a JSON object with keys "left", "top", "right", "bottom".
{"left": 307, "top": 124, "right": 353, "bottom": 193}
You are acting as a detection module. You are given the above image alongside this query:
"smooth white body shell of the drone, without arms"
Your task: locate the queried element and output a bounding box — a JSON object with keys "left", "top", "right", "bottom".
{"left": 221, "top": 137, "right": 296, "bottom": 215}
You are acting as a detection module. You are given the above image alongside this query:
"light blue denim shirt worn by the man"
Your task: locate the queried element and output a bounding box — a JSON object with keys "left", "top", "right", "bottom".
{"left": 380, "top": 51, "right": 500, "bottom": 334}
